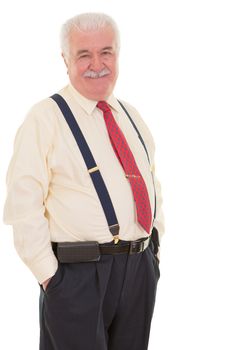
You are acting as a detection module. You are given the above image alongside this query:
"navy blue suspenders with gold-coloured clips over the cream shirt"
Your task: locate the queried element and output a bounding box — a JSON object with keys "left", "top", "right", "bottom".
{"left": 51, "top": 94, "right": 155, "bottom": 243}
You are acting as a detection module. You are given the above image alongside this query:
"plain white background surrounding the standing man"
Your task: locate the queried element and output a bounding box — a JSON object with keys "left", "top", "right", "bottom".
{"left": 0, "top": 0, "right": 233, "bottom": 350}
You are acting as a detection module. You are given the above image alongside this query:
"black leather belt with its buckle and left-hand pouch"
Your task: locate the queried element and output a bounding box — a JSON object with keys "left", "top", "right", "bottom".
{"left": 52, "top": 237, "right": 150, "bottom": 263}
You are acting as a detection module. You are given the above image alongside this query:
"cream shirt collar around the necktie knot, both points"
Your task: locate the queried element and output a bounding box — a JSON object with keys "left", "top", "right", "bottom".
{"left": 69, "top": 84, "right": 121, "bottom": 115}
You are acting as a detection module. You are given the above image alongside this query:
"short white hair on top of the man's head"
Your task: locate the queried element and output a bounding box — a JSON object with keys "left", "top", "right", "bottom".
{"left": 60, "top": 12, "right": 120, "bottom": 57}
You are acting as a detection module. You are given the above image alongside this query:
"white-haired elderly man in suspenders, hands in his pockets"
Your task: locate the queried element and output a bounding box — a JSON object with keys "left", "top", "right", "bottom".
{"left": 4, "top": 13, "right": 163, "bottom": 350}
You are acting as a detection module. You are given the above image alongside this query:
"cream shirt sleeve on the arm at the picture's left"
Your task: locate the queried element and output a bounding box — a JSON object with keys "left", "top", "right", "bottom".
{"left": 4, "top": 104, "right": 58, "bottom": 283}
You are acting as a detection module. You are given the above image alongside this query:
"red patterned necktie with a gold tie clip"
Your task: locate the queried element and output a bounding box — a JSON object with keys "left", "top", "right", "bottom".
{"left": 97, "top": 101, "right": 152, "bottom": 233}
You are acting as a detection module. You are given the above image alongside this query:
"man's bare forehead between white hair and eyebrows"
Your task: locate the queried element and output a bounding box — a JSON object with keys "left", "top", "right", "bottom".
{"left": 69, "top": 27, "right": 116, "bottom": 52}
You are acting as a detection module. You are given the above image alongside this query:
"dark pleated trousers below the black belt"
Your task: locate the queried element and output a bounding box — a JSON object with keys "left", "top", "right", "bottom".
{"left": 40, "top": 241, "right": 159, "bottom": 350}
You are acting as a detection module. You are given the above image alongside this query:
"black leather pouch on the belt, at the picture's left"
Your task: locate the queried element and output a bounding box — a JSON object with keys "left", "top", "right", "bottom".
{"left": 56, "top": 241, "right": 101, "bottom": 263}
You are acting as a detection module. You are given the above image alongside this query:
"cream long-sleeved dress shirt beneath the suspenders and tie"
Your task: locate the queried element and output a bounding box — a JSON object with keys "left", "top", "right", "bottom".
{"left": 4, "top": 85, "right": 163, "bottom": 283}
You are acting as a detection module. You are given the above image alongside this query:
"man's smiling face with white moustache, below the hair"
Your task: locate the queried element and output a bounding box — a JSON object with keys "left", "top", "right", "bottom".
{"left": 63, "top": 26, "right": 118, "bottom": 101}
